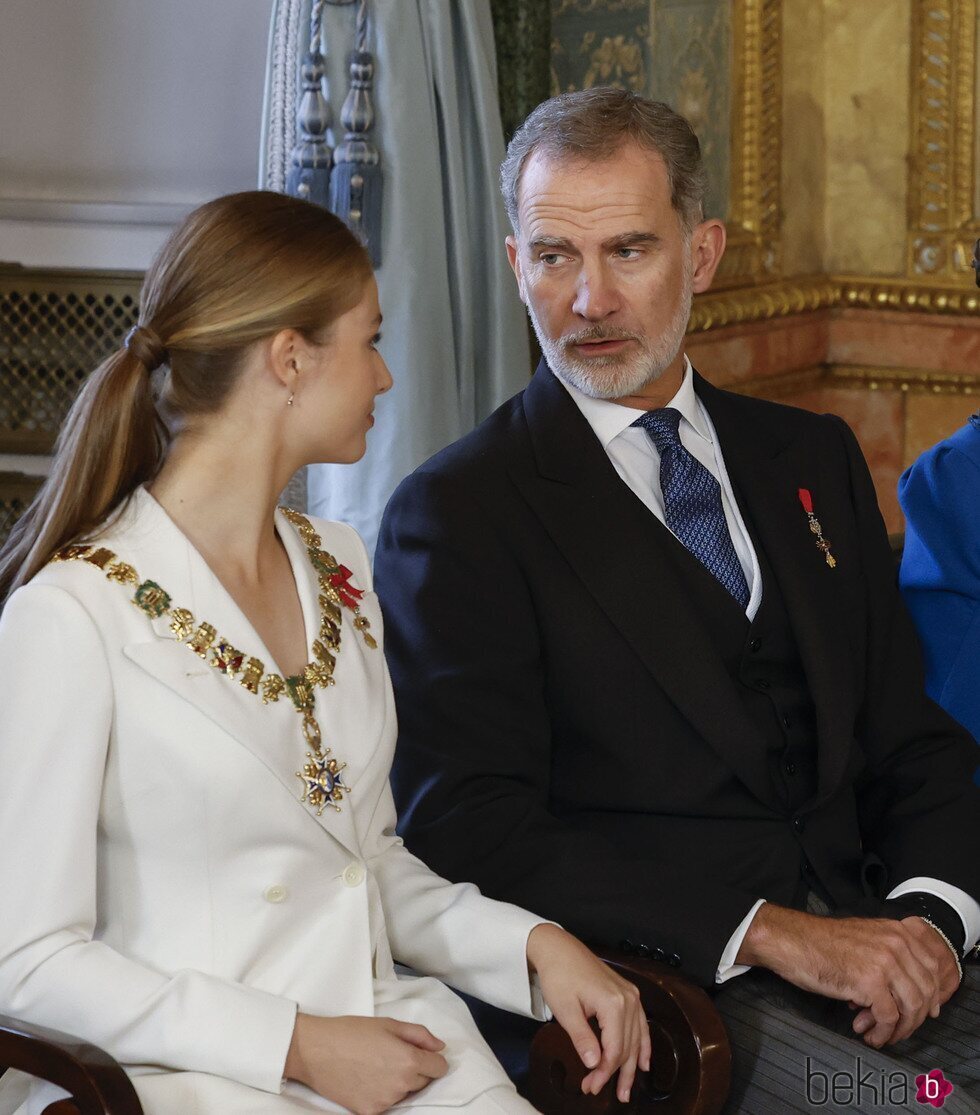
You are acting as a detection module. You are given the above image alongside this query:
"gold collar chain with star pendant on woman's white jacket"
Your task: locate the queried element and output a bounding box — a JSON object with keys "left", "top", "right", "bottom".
{"left": 51, "top": 507, "right": 378, "bottom": 817}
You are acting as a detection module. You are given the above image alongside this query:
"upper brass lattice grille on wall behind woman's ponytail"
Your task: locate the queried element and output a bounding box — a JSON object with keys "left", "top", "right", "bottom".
{"left": 0, "top": 265, "right": 143, "bottom": 453}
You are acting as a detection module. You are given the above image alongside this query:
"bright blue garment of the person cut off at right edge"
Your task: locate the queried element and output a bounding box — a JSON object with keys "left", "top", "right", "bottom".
{"left": 899, "top": 415, "right": 980, "bottom": 767}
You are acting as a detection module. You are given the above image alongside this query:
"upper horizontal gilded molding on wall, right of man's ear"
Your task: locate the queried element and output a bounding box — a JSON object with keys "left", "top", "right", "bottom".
{"left": 688, "top": 275, "right": 980, "bottom": 333}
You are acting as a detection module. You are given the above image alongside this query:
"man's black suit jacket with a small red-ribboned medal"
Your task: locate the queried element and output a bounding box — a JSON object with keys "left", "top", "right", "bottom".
{"left": 376, "top": 367, "right": 980, "bottom": 985}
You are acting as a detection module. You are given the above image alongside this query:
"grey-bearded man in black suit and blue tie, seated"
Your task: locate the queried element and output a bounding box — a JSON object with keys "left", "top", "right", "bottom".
{"left": 377, "top": 89, "right": 980, "bottom": 1113}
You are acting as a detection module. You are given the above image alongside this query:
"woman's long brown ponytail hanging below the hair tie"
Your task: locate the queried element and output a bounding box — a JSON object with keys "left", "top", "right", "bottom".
{"left": 0, "top": 327, "right": 167, "bottom": 607}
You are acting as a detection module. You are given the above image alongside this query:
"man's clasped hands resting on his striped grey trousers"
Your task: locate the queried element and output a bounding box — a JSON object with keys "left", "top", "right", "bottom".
{"left": 737, "top": 902, "right": 959, "bottom": 1049}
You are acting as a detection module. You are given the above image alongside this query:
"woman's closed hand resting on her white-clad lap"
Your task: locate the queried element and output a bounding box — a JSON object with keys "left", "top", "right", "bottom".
{"left": 284, "top": 1014, "right": 448, "bottom": 1115}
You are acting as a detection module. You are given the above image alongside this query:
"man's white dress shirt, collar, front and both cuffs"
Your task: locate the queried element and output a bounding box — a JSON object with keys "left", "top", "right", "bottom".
{"left": 555, "top": 357, "right": 980, "bottom": 983}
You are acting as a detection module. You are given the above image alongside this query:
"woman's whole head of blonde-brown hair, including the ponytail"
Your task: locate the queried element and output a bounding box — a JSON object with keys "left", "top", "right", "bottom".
{"left": 0, "top": 191, "right": 371, "bottom": 605}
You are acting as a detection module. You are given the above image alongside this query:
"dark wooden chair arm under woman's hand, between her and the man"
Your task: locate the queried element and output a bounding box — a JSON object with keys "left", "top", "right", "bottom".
{"left": 530, "top": 949, "right": 731, "bottom": 1115}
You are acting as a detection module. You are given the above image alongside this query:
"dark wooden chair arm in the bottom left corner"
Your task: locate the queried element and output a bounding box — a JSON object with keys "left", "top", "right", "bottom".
{"left": 0, "top": 1015, "right": 143, "bottom": 1115}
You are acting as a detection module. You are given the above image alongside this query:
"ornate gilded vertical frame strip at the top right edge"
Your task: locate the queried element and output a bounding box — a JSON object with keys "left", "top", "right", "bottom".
{"left": 908, "top": 0, "right": 980, "bottom": 279}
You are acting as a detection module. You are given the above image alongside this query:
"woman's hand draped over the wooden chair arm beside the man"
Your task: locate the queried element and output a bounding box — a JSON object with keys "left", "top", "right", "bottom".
{"left": 527, "top": 924, "right": 650, "bottom": 1103}
